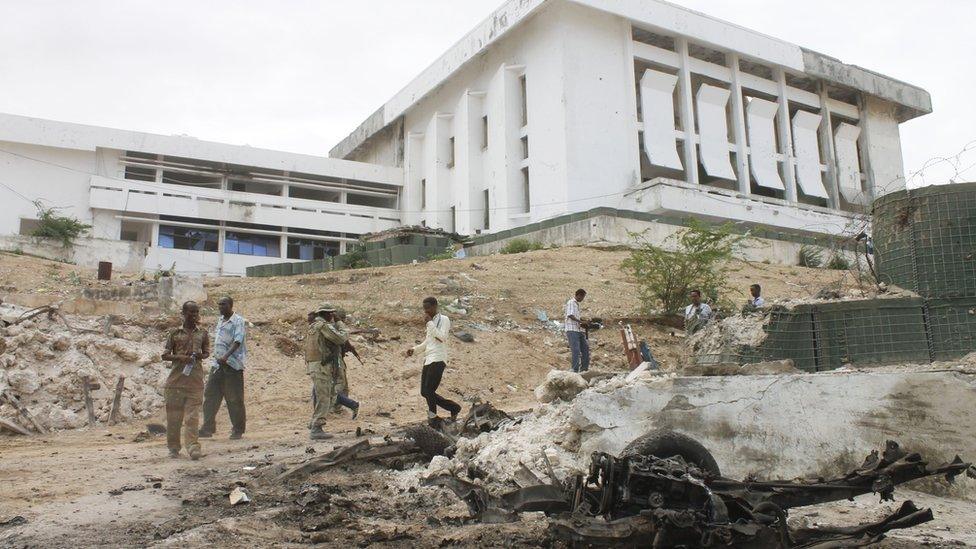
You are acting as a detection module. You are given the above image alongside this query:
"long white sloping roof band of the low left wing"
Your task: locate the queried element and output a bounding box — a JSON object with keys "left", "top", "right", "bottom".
{"left": 0, "top": 113, "right": 403, "bottom": 187}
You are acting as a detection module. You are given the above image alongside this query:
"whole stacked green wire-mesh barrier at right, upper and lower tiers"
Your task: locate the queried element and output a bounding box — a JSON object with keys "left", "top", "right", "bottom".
{"left": 691, "top": 183, "right": 976, "bottom": 371}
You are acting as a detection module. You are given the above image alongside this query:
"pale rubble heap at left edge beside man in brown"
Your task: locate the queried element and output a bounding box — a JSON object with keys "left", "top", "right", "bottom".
{"left": 0, "top": 317, "right": 166, "bottom": 429}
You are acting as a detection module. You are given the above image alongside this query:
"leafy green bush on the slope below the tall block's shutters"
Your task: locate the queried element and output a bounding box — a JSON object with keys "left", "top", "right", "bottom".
{"left": 621, "top": 219, "right": 748, "bottom": 315}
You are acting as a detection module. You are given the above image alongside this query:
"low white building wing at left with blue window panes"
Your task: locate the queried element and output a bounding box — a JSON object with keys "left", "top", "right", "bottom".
{"left": 0, "top": 114, "right": 403, "bottom": 274}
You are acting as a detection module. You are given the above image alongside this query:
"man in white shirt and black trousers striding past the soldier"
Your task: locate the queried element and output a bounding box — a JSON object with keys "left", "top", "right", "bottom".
{"left": 407, "top": 297, "right": 461, "bottom": 420}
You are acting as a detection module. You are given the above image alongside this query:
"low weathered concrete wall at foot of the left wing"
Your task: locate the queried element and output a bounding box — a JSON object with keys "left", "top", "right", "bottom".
{"left": 0, "top": 235, "right": 148, "bottom": 272}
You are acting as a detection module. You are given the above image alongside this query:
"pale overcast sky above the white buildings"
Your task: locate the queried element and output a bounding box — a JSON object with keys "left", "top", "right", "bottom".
{"left": 0, "top": 0, "right": 976, "bottom": 182}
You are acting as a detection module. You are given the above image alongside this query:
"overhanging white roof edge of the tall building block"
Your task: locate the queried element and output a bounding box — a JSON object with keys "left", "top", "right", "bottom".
{"left": 329, "top": 0, "right": 932, "bottom": 158}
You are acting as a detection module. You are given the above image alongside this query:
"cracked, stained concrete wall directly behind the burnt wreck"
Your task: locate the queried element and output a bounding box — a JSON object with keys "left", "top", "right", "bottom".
{"left": 571, "top": 371, "right": 976, "bottom": 479}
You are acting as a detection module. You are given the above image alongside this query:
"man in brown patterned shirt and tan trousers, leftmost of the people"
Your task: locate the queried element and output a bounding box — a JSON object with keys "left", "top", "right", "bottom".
{"left": 162, "top": 301, "right": 210, "bottom": 460}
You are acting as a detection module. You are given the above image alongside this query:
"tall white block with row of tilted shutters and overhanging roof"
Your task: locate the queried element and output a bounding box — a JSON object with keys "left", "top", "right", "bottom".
{"left": 331, "top": 0, "right": 931, "bottom": 240}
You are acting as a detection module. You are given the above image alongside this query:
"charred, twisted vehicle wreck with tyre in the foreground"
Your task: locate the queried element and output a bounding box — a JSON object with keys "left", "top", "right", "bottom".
{"left": 427, "top": 431, "right": 974, "bottom": 548}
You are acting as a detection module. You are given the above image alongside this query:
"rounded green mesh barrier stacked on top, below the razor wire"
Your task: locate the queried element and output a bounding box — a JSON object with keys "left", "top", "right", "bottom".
{"left": 873, "top": 183, "right": 976, "bottom": 298}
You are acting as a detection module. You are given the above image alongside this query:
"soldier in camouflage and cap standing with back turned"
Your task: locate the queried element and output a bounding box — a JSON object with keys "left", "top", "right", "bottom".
{"left": 305, "top": 303, "right": 349, "bottom": 440}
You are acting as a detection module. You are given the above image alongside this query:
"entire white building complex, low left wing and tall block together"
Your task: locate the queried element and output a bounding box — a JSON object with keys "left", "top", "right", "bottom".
{"left": 0, "top": 0, "right": 931, "bottom": 274}
